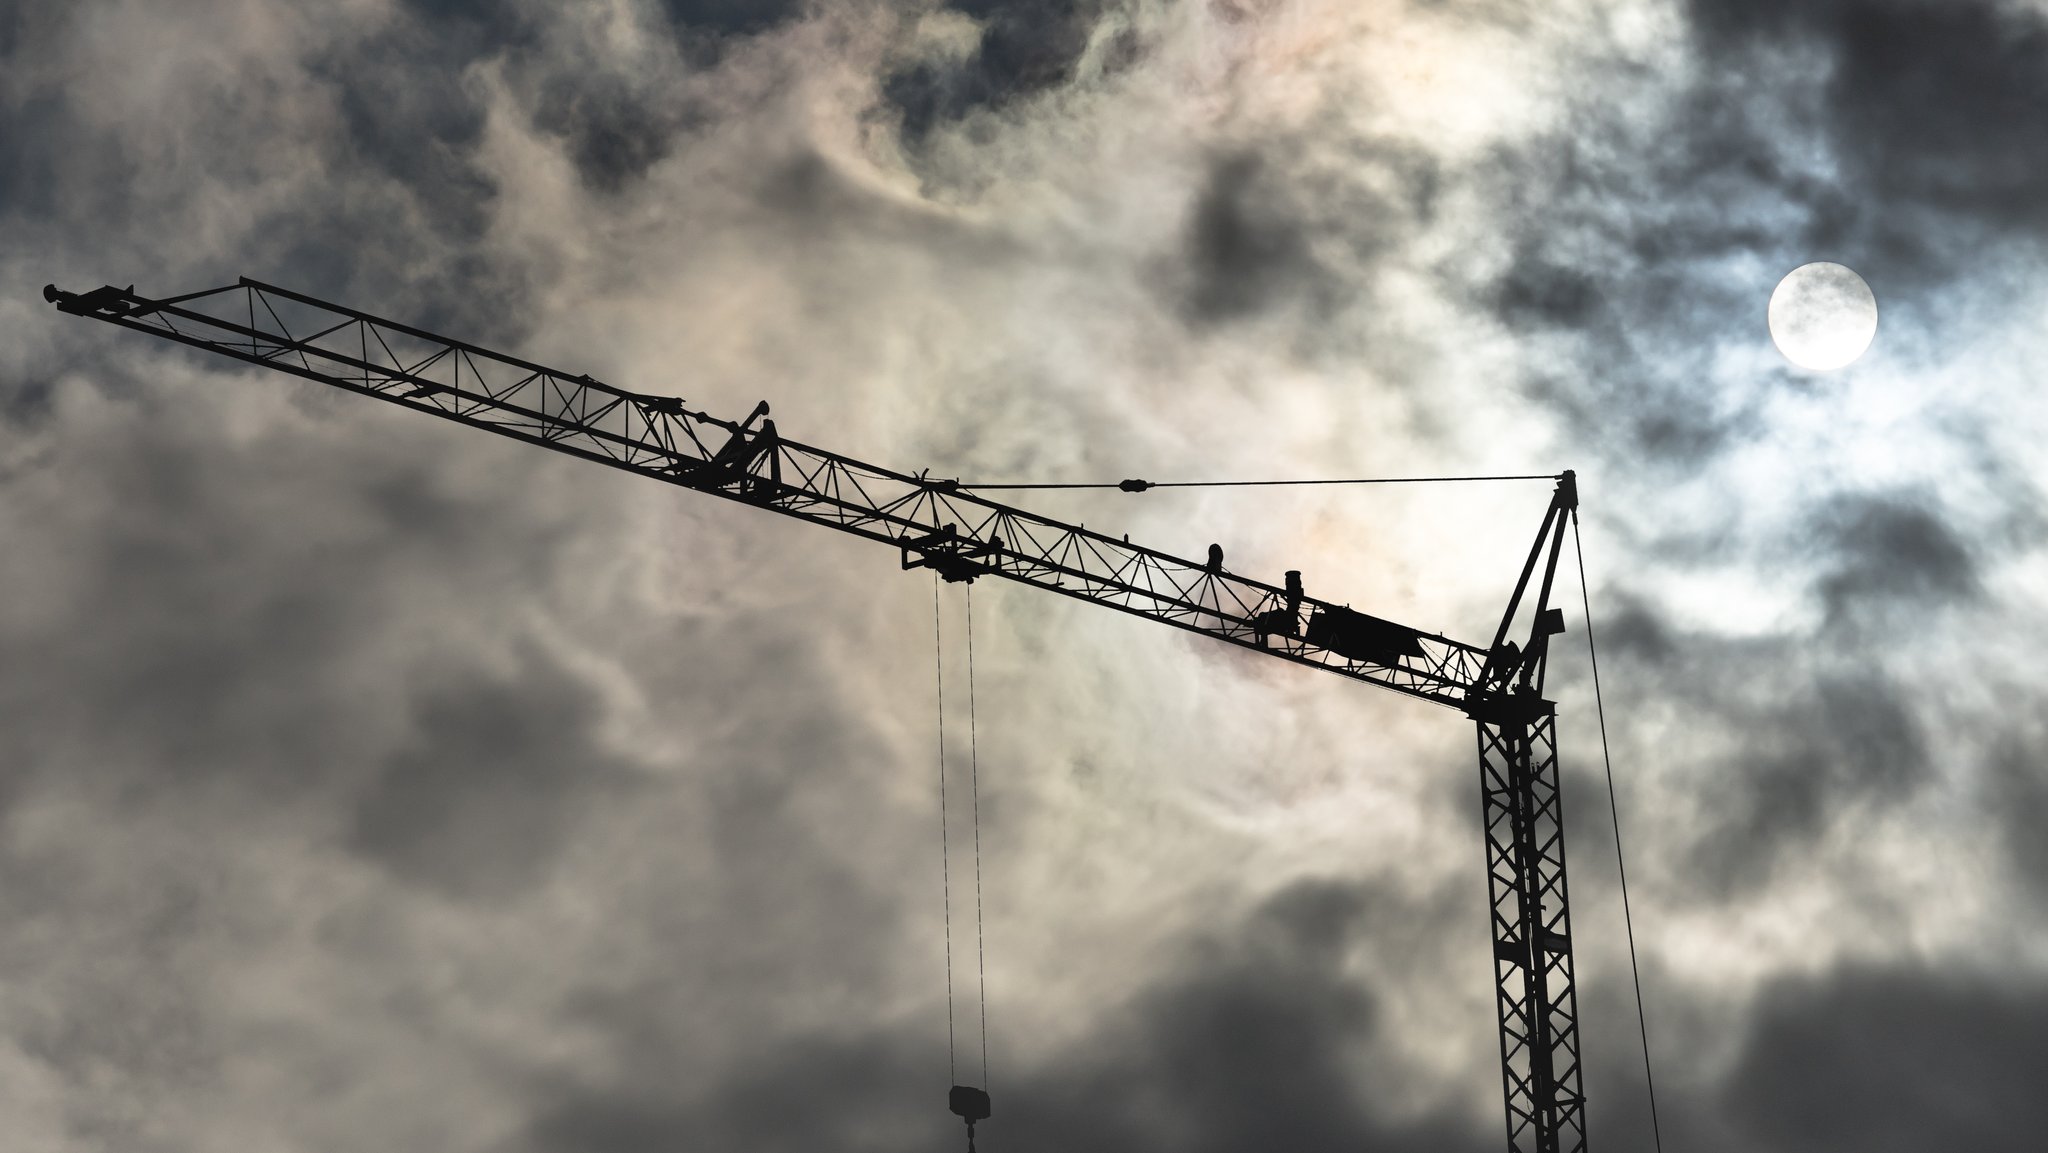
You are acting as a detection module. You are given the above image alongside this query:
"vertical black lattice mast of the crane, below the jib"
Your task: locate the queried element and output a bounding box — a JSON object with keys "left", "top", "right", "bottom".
{"left": 1475, "top": 696, "right": 1585, "bottom": 1153}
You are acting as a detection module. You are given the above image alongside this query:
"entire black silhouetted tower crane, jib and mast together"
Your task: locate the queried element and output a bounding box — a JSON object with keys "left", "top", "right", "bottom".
{"left": 43, "top": 279, "right": 1585, "bottom": 1153}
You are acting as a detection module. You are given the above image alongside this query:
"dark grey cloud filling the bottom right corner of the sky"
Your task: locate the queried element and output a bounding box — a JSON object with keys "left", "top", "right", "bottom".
{"left": 1718, "top": 969, "right": 2048, "bottom": 1153}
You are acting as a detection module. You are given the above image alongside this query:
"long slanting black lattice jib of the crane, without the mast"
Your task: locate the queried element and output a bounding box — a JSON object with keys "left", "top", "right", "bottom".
{"left": 48, "top": 279, "right": 1485, "bottom": 709}
